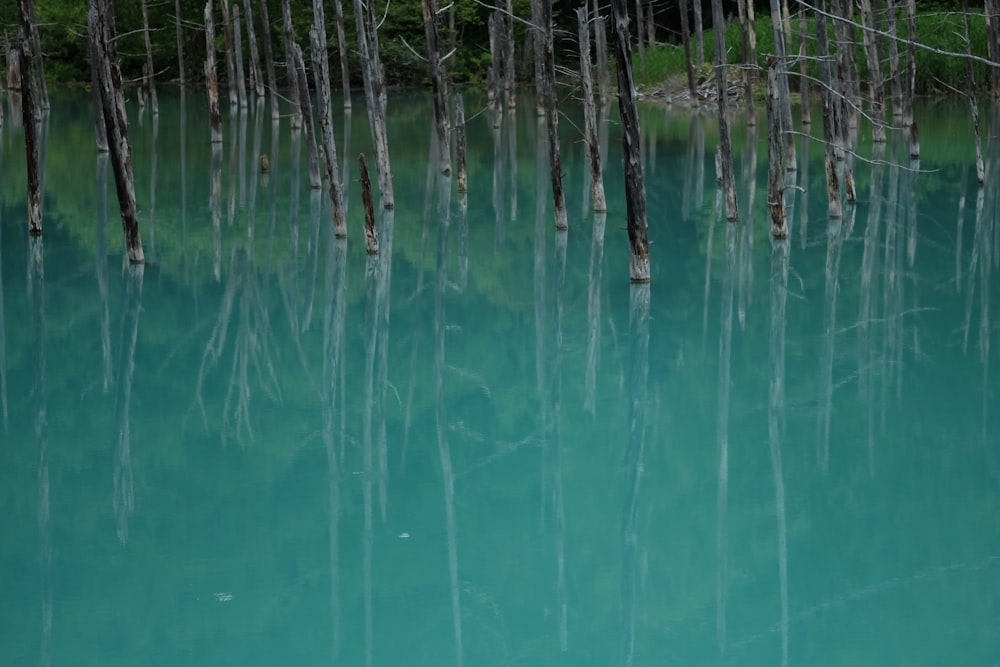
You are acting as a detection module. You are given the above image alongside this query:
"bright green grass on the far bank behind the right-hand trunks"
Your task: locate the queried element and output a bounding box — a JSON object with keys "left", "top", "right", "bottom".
{"left": 632, "top": 11, "right": 988, "bottom": 94}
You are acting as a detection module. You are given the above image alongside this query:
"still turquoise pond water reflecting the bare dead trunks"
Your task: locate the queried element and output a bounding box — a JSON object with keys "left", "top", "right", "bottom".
{"left": 0, "top": 91, "right": 1000, "bottom": 666}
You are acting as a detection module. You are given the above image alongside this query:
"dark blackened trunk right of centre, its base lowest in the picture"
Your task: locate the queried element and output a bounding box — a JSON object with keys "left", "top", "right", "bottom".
{"left": 611, "top": 0, "right": 650, "bottom": 283}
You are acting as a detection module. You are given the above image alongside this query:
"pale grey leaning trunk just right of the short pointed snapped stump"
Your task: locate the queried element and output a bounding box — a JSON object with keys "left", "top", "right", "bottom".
{"left": 354, "top": 0, "right": 396, "bottom": 208}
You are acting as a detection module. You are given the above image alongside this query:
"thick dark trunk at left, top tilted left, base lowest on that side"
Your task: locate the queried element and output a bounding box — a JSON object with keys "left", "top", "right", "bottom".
{"left": 87, "top": 0, "right": 145, "bottom": 264}
